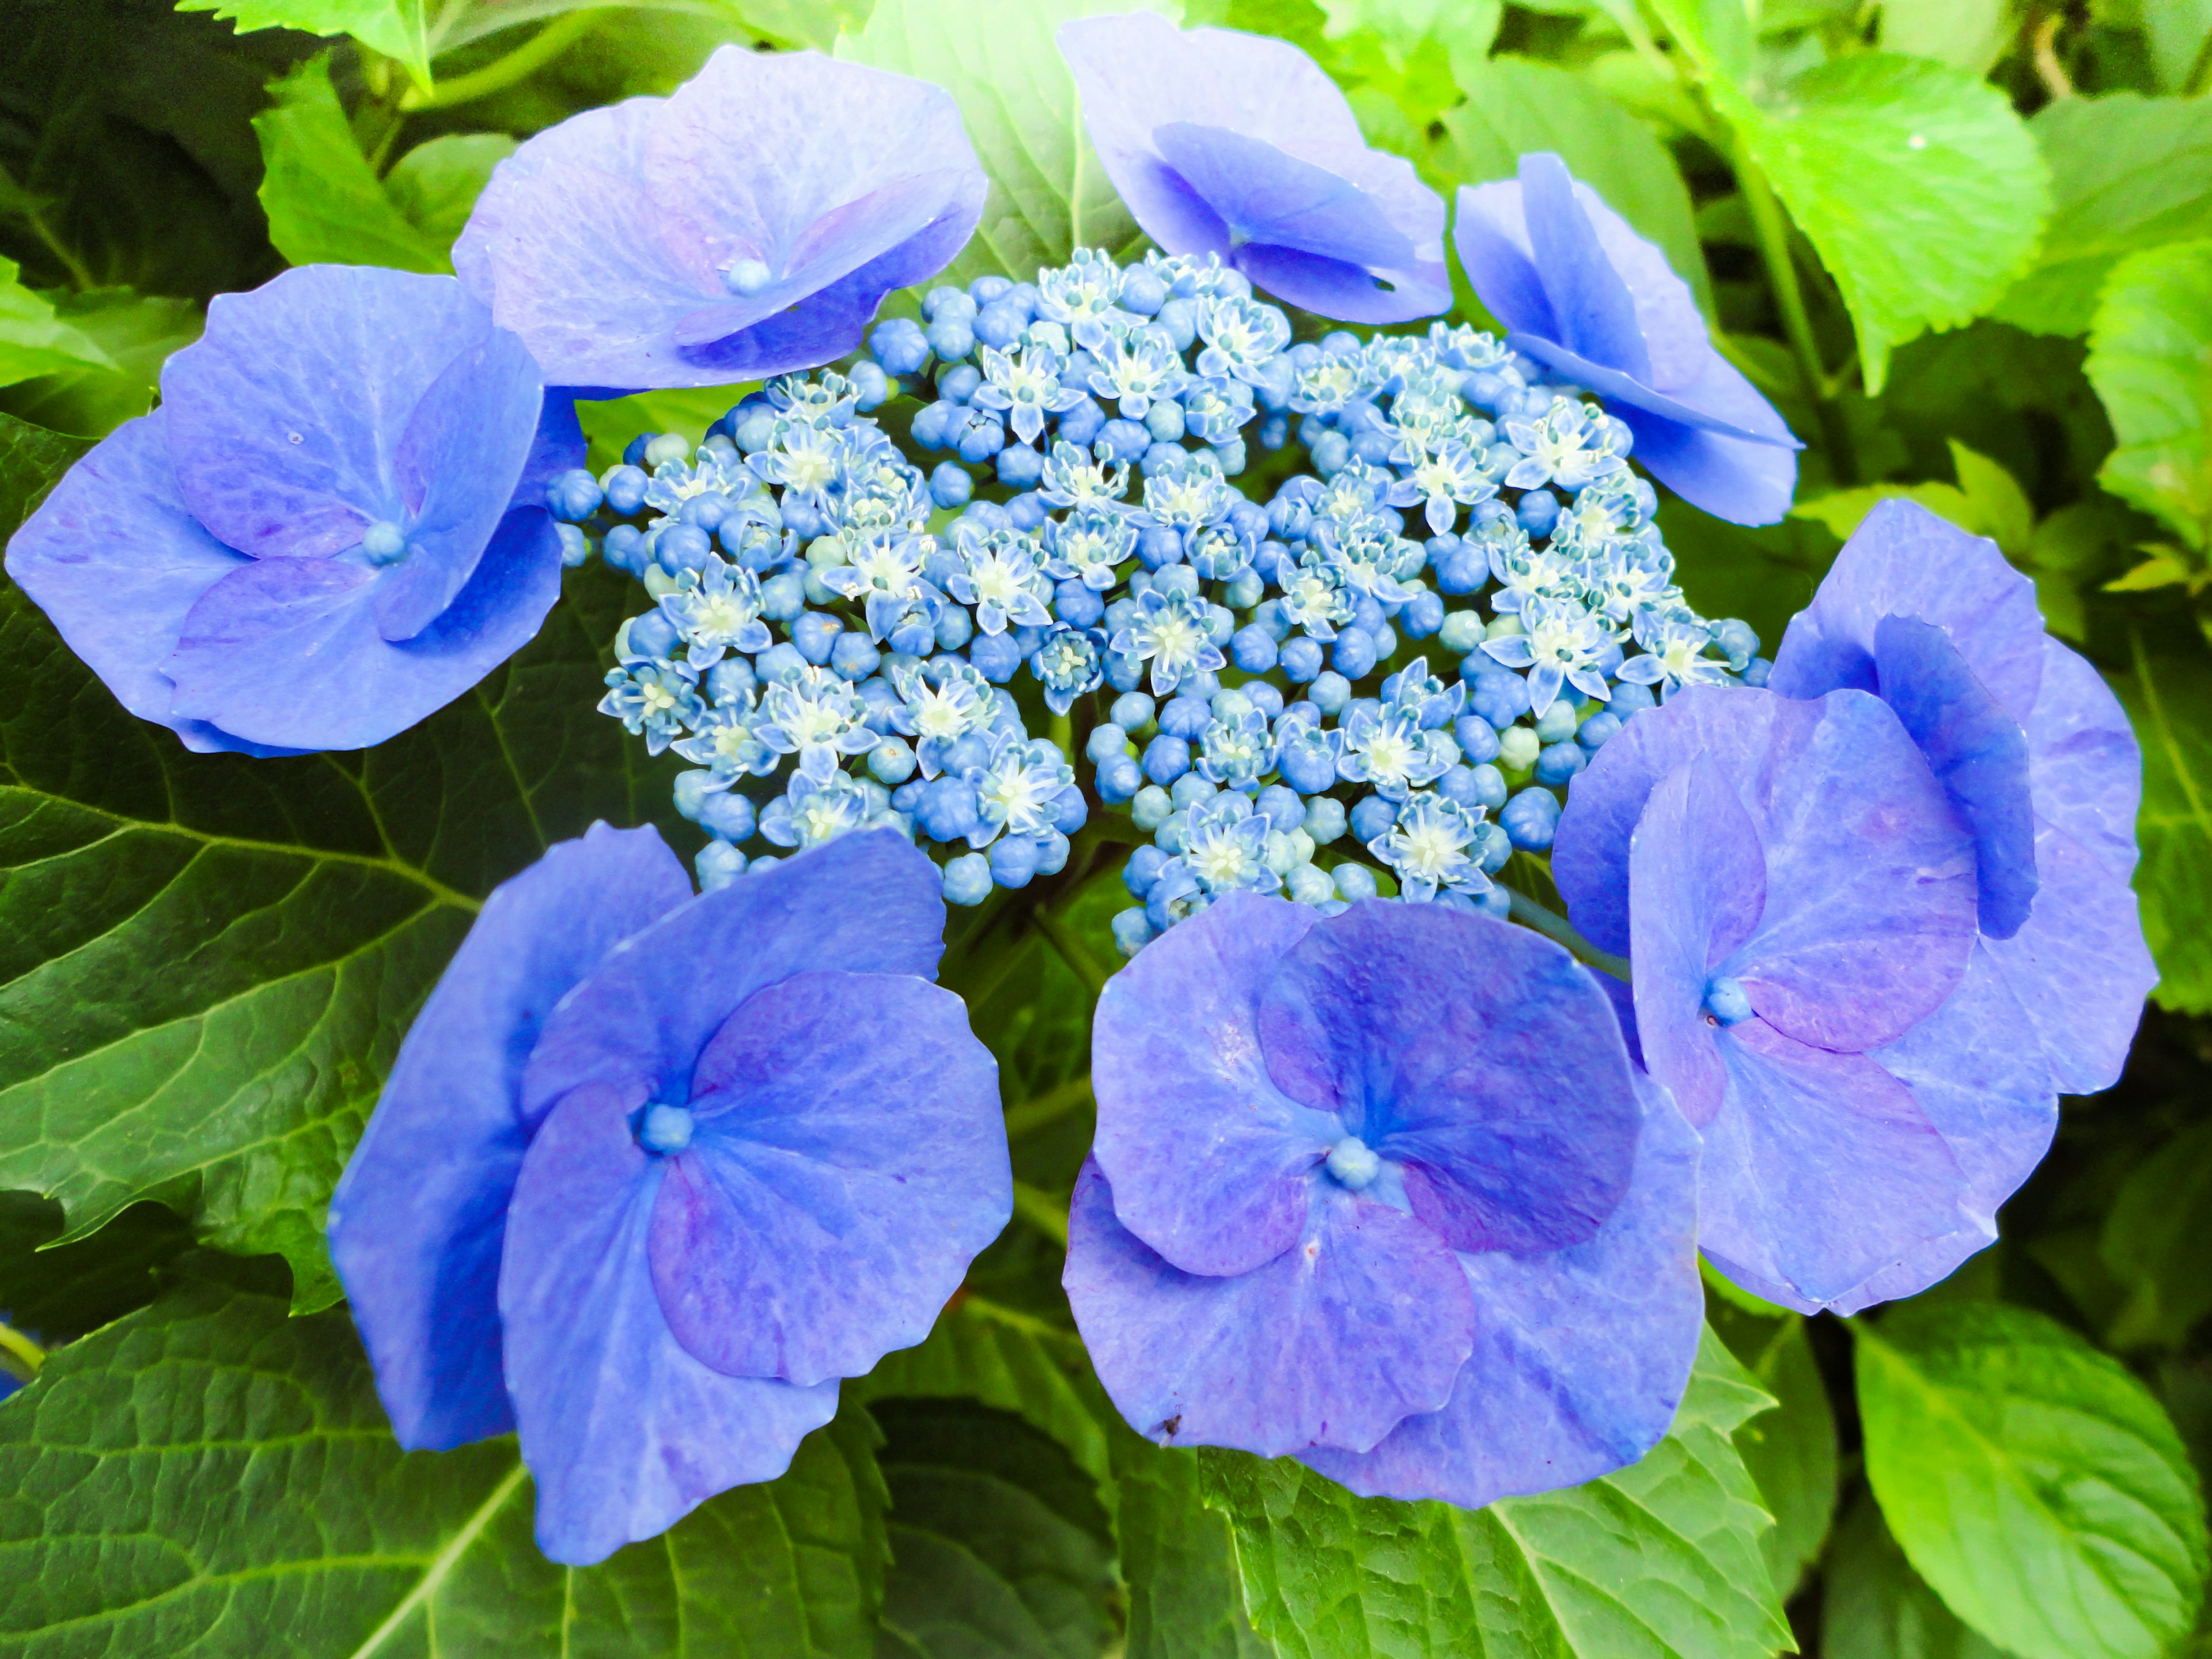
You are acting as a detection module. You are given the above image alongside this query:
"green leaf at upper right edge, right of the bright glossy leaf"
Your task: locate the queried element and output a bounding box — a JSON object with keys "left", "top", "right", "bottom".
{"left": 1991, "top": 93, "right": 2212, "bottom": 334}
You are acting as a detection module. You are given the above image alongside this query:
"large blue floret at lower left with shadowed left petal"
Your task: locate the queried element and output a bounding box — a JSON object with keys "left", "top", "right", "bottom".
{"left": 329, "top": 825, "right": 1013, "bottom": 1564}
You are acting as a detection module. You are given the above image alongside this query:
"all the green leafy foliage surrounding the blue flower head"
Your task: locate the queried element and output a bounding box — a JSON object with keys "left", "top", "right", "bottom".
{"left": 0, "top": 0, "right": 2212, "bottom": 1659}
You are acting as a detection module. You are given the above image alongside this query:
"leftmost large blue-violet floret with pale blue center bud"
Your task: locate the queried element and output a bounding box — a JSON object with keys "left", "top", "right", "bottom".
{"left": 7, "top": 266, "right": 584, "bottom": 754}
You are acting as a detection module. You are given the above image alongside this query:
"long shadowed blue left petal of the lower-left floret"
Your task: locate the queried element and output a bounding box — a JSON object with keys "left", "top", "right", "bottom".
{"left": 329, "top": 823, "right": 690, "bottom": 1451}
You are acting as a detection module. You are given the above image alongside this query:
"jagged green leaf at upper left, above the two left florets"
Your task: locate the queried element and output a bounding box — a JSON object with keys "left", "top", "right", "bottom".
{"left": 255, "top": 55, "right": 453, "bottom": 272}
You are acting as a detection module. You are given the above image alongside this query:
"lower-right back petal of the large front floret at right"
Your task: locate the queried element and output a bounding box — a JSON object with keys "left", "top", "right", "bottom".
{"left": 1832, "top": 942, "right": 2059, "bottom": 1314}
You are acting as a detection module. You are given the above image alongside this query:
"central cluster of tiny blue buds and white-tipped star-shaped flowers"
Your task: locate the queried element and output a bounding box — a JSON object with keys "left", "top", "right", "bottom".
{"left": 548, "top": 250, "right": 1767, "bottom": 953}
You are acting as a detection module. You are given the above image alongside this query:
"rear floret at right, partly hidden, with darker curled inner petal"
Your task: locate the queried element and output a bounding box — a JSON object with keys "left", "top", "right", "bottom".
{"left": 1770, "top": 500, "right": 2159, "bottom": 1095}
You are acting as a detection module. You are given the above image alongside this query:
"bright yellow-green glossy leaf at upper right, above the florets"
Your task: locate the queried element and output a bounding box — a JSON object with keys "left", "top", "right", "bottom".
{"left": 1714, "top": 53, "right": 2051, "bottom": 396}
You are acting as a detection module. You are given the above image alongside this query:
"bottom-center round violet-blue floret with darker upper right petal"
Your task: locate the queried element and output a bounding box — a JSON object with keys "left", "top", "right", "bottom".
{"left": 1066, "top": 893, "right": 1701, "bottom": 1506}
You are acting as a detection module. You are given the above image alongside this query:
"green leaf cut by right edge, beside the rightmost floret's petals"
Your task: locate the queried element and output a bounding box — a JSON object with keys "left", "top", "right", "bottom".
{"left": 2112, "top": 643, "right": 2212, "bottom": 1013}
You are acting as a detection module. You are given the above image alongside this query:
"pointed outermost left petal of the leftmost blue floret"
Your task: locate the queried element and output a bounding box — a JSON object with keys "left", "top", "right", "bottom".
{"left": 7, "top": 409, "right": 274, "bottom": 754}
